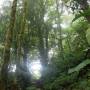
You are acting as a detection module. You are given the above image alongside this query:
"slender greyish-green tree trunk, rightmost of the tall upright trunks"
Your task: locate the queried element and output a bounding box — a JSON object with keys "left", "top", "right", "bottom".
{"left": 56, "top": 0, "right": 64, "bottom": 60}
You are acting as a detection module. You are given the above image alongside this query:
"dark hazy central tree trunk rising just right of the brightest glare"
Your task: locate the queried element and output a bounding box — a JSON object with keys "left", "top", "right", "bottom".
{"left": 38, "top": 0, "right": 48, "bottom": 67}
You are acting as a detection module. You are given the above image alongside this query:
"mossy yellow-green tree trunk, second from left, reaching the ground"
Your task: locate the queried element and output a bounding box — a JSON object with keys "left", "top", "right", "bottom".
{"left": 16, "top": 0, "right": 27, "bottom": 90}
